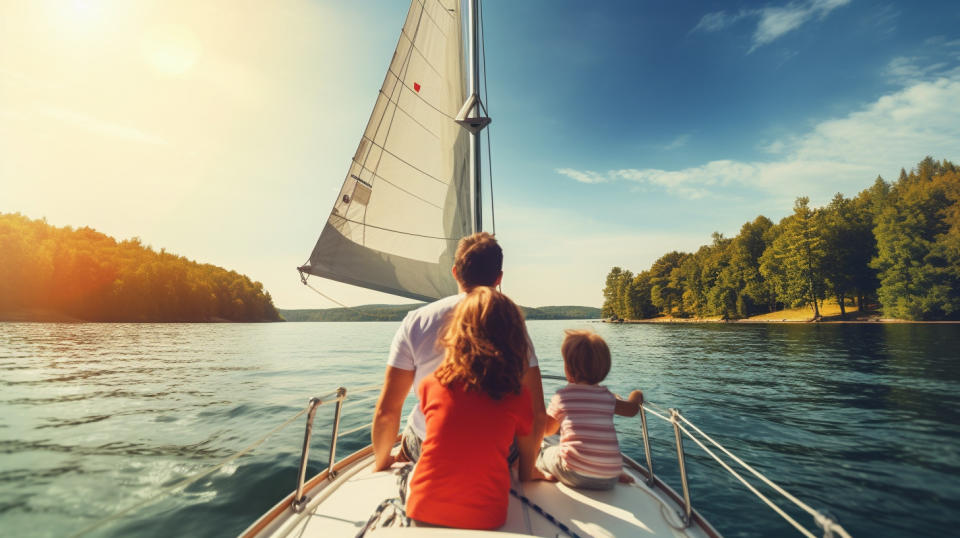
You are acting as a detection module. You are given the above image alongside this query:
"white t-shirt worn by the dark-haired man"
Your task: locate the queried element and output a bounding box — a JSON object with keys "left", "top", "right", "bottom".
{"left": 387, "top": 293, "right": 538, "bottom": 439}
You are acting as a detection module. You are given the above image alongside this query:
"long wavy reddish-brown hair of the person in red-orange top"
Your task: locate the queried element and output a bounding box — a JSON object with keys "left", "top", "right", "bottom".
{"left": 434, "top": 286, "right": 530, "bottom": 400}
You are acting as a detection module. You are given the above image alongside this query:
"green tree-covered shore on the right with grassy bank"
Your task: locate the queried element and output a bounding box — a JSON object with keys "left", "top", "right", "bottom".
{"left": 603, "top": 157, "right": 960, "bottom": 320}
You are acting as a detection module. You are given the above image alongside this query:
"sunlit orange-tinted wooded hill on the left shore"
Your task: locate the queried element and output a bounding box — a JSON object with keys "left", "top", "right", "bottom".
{"left": 0, "top": 213, "right": 281, "bottom": 322}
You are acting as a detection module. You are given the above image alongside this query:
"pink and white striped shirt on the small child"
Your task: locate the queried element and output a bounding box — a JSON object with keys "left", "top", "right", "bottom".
{"left": 547, "top": 383, "right": 623, "bottom": 478}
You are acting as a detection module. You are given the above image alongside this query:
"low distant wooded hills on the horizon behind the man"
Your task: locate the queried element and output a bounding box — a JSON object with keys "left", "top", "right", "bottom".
{"left": 279, "top": 303, "right": 600, "bottom": 321}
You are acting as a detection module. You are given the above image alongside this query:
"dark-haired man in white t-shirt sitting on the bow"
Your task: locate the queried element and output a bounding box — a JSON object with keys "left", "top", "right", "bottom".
{"left": 371, "top": 232, "right": 549, "bottom": 480}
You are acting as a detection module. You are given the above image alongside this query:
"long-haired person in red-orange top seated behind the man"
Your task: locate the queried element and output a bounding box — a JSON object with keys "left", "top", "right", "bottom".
{"left": 407, "top": 287, "right": 533, "bottom": 529}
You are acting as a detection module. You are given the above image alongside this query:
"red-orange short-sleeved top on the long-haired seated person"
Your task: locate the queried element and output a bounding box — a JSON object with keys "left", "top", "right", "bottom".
{"left": 407, "top": 375, "right": 533, "bottom": 529}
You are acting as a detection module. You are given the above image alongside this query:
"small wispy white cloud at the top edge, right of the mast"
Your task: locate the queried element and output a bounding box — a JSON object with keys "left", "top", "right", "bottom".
{"left": 692, "top": 0, "right": 851, "bottom": 53}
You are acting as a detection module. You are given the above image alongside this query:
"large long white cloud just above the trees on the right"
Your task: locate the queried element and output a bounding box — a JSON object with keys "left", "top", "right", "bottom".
{"left": 565, "top": 77, "right": 960, "bottom": 205}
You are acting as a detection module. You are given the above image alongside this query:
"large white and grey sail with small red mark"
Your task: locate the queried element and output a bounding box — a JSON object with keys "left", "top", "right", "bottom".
{"left": 300, "top": 0, "right": 473, "bottom": 300}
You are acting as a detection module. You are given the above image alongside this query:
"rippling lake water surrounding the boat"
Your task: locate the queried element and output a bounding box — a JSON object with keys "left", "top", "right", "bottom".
{"left": 0, "top": 321, "right": 960, "bottom": 536}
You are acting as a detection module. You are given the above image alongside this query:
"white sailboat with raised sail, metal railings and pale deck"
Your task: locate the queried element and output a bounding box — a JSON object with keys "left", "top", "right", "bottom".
{"left": 242, "top": 0, "right": 845, "bottom": 538}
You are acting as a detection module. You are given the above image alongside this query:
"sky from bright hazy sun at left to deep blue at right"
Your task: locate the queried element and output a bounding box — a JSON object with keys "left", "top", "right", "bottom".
{"left": 0, "top": 0, "right": 960, "bottom": 308}
